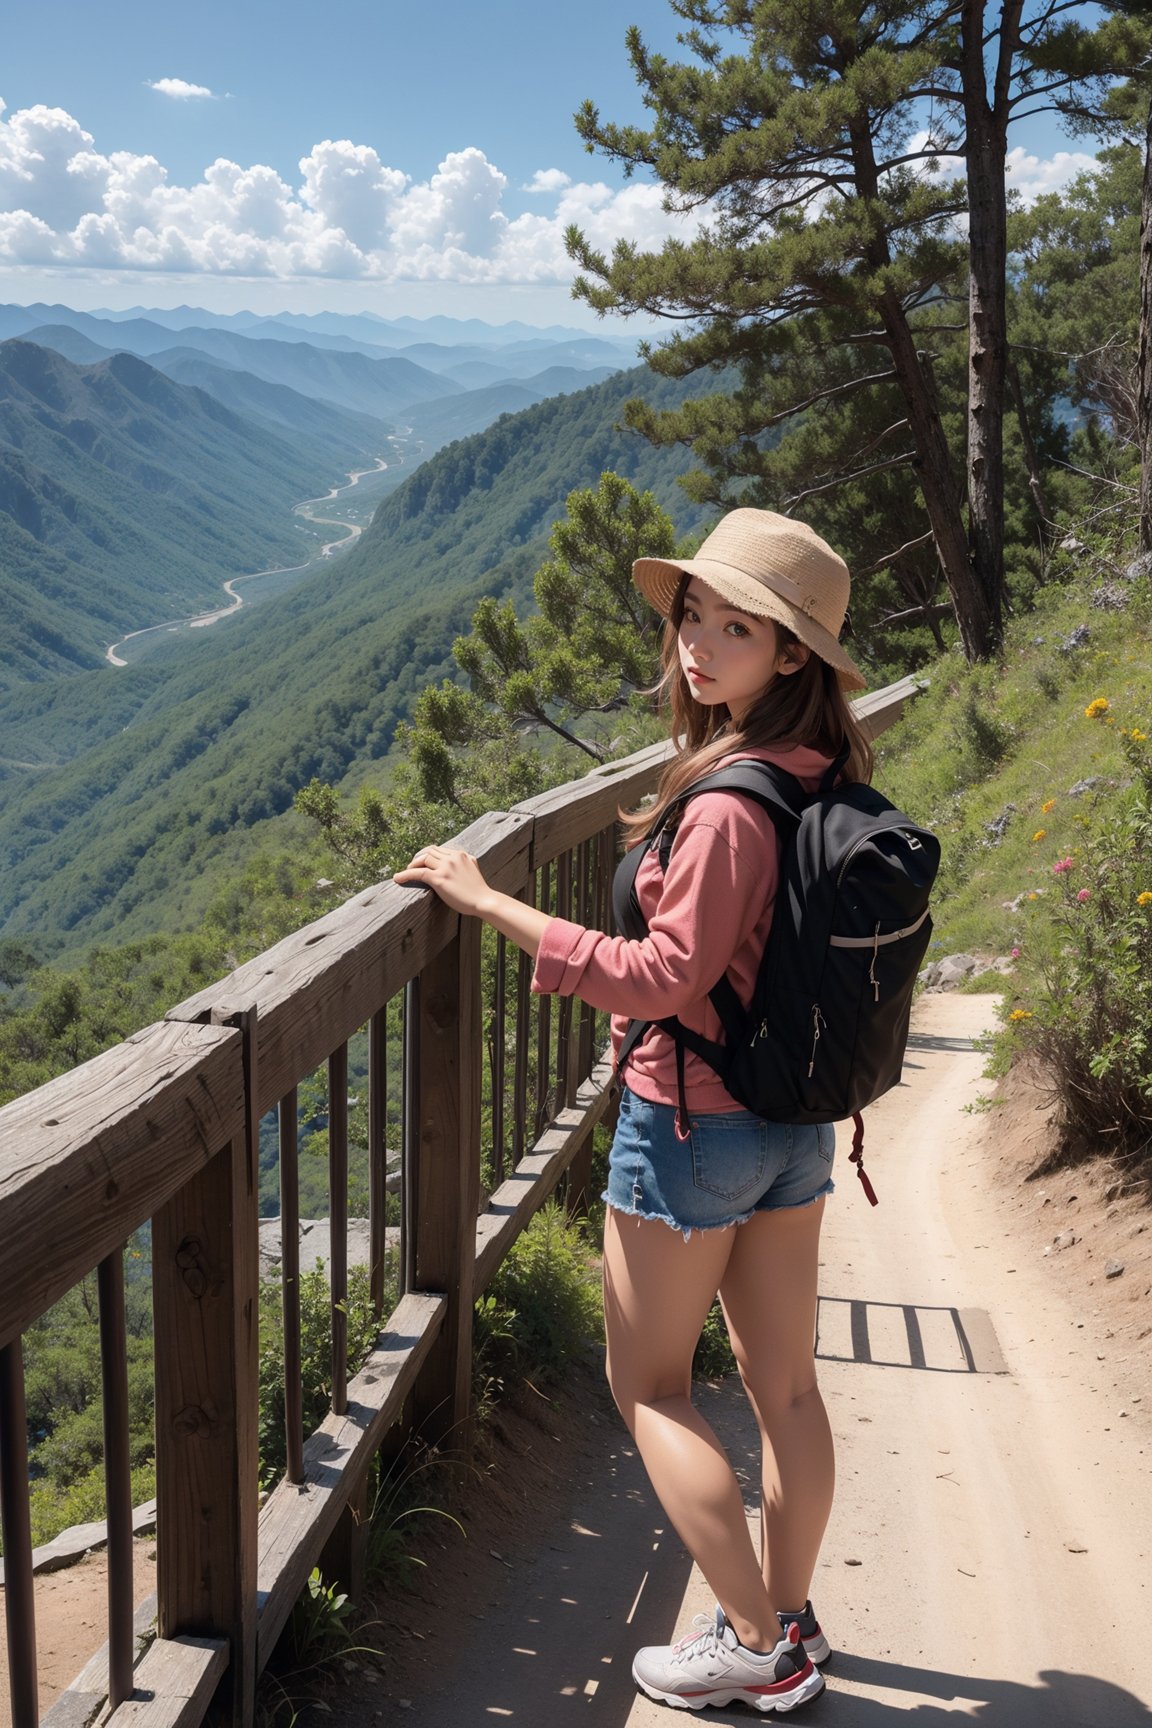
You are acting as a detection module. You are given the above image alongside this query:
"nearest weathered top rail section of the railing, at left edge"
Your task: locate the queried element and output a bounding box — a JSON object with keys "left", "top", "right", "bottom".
{"left": 0, "top": 1023, "right": 245, "bottom": 1344}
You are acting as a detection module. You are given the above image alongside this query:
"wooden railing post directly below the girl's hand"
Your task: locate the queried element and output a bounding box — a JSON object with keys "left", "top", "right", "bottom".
{"left": 411, "top": 918, "right": 482, "bottom": 1453}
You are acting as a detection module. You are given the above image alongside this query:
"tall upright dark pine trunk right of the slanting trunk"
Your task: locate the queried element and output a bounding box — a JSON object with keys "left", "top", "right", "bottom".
{"left": 960, "top": 0, "right": 1021, "bottom": 653}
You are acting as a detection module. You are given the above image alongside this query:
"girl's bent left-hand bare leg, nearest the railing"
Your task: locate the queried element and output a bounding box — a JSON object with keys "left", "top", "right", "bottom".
{"left": 604, "top": 1208, "right": 781, "bottom": 1650}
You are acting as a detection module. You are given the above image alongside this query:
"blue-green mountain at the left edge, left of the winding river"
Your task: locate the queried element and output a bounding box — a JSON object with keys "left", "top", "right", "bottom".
{"left": 0, "top": 339, "right": 360, "bottom": 680}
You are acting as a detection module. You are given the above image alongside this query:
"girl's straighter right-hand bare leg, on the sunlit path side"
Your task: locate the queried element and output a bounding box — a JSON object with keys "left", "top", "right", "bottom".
{"left": 720, "top": 1199, "right": 836, "bottom": 1609}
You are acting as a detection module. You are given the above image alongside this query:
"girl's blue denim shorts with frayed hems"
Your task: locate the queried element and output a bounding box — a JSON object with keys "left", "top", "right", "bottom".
{"left": 601, "top": 1087, "right": 836, "bottom": 1237}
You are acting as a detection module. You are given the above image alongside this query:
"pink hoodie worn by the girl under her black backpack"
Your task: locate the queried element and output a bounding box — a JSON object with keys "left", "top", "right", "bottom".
{"left": 532, "top": 746, "right": 829, "bottom": 1113}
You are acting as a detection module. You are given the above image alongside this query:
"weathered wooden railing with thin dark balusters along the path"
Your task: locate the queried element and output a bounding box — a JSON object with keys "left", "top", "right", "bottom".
{"left": 0, "top": 679, "right": 917, "bottom": 1728}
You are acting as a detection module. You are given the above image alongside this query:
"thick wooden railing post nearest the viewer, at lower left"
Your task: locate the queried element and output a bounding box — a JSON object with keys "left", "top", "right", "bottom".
{"left": 152, "top": 1009, "right": 259, "bottom": 1728}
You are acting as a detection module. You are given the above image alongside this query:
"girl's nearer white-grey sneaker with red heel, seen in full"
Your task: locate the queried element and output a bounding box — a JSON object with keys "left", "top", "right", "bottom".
{"left": 632, "top": 1609, "right": 824, "bottom": 1712}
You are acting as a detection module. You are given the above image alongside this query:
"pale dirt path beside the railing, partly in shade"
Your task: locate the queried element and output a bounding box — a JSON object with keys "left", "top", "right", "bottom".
{"left": 326, "top": 995, "right": 1152, "bottom": 1728}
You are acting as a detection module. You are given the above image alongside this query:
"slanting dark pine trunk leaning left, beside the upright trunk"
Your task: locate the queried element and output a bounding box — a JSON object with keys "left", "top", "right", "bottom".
{"left": 881, "top": 289, "right": 1000, "bottom": 662}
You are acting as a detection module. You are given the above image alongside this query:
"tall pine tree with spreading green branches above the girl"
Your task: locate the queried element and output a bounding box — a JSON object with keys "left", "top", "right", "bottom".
{"left": 568, "top": 0, "right": 1135, "bottom": 658}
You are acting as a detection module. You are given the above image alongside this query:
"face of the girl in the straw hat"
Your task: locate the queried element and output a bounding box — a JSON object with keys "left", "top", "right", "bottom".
{"left": 679, "top": 575, "right": 808, "bottom": 726}
